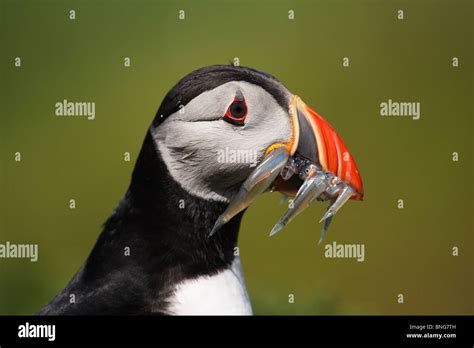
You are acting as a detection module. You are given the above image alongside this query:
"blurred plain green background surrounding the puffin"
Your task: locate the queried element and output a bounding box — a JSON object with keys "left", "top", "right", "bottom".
{"left": 0, "top": 0, "right": 474, "bottom": 314}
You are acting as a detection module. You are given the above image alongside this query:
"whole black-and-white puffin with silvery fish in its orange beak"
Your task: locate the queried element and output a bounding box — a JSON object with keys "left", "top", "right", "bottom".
{"left": 37, "top": 65, "right": 363, "bottom": 315}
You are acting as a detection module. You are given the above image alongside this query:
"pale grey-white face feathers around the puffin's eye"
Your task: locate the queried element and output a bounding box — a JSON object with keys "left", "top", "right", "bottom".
{"left": 151, "top": 81, "right": 292, "bottom": 202}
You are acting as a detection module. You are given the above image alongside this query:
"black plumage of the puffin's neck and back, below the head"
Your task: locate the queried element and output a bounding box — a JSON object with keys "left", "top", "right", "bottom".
{"left": 38, "top": 134, "right": 242, "bottom": 315}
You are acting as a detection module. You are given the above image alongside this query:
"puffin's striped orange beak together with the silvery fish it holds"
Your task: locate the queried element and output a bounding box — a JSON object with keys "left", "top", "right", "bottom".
{"left": 210, "top": 96, "right": 364, "bottom": 242}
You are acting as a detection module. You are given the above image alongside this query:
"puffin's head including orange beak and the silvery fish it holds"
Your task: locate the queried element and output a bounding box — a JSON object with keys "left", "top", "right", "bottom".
{"left": 150, "top": 65, "right": 363, "bottom": 238}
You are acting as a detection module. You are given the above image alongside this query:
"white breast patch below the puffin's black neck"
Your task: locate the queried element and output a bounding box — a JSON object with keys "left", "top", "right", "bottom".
{"left": 168, "top": 257, "right": 252, "bottom": 315}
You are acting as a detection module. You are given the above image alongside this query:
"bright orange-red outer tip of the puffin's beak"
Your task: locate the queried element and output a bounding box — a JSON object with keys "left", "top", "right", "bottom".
{"left": 305, "top": 105, "right": 364, "bottom": 200}
